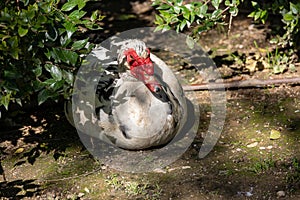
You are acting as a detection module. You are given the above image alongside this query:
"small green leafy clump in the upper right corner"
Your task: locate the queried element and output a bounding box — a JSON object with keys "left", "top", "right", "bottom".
{"left": 249, "top": 0, "right": 300, "bottom": 47}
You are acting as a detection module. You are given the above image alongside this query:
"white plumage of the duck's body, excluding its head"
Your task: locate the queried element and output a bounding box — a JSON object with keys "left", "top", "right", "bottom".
{"left": 67, "top": 41, "right": 187, "bottom": 150}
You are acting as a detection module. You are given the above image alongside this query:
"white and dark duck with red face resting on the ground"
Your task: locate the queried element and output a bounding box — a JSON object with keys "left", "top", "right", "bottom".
{"left": 65, "top": 39, "right": 187, "bottom": 150}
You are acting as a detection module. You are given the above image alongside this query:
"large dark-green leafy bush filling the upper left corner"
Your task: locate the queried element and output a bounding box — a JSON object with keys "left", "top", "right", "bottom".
{"left": 0, "top": 0, "right": 102, "bottom": 109}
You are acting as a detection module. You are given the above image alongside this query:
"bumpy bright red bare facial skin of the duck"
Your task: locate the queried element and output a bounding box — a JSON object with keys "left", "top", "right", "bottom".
{"left": 124, "top": 48, "right": 161, "bottom": 92}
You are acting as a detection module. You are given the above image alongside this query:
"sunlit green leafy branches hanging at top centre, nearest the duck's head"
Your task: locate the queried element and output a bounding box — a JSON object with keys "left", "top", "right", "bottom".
{"left": 152, "top": 0, "right": 240, "bottom": 39}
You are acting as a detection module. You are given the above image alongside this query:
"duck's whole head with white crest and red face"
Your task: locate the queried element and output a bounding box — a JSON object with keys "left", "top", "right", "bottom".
{"left": 118, "top": 39, "right": 162, "bottom": 93}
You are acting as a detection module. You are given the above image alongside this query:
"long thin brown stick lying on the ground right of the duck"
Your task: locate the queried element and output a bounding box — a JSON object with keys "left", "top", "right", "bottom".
{"left": 182, "top": 77, "right": 300, "bottom": 91}
